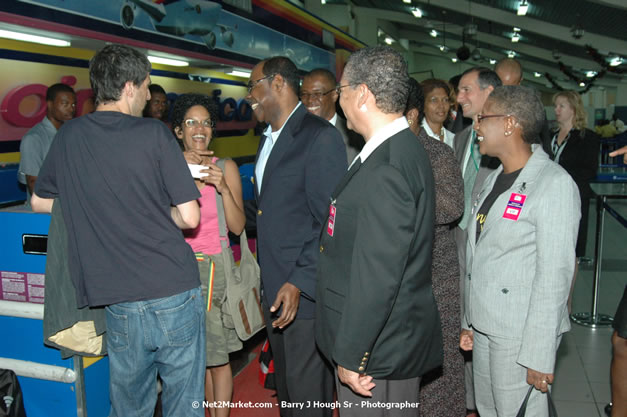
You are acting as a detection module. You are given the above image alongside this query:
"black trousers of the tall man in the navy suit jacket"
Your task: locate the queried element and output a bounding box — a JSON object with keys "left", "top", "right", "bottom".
{"left": 263, "top": 303, "right": 334, "bottom": 417}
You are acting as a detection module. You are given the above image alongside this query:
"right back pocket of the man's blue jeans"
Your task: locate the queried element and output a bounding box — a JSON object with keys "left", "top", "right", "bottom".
{"left": 155, "top": 291, "right": 201, "bottom": 346}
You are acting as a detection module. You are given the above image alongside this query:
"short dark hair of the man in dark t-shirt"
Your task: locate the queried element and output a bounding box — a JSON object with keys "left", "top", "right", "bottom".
{"left": 89, "top": 44, "right": 151, "bottom": 104}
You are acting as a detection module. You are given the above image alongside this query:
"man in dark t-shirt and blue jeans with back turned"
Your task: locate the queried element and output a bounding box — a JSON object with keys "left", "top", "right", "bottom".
{"left": 31, "top": 45, "right": 205, "bottom": 417}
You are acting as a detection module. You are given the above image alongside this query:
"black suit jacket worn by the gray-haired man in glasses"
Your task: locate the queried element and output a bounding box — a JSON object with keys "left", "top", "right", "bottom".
{"left": 316, "top": 129, "right": 442, "bottom": 379}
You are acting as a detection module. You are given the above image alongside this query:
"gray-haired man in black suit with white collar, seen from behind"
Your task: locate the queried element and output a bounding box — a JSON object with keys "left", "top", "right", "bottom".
{"left": 316, "top": 47, "right": 442, "bottom": 417}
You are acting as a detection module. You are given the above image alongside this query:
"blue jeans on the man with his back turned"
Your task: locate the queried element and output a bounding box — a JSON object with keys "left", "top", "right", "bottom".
{"left": 106, "top": 287, "right": 205, "bottom": 417}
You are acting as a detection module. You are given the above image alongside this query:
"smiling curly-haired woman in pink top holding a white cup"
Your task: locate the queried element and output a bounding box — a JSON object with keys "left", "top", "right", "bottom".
{"left": 172, "top": 94, "right": 246, "bottom": 417}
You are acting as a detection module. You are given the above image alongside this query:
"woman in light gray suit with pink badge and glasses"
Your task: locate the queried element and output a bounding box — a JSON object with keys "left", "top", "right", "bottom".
{"left": 460, "top": 86, "right": 580, "bottom": 417}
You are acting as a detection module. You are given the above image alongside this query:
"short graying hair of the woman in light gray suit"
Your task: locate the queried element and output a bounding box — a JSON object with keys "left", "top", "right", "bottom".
{"left": 487, "top": 85, "right": 546, "bottom": 144}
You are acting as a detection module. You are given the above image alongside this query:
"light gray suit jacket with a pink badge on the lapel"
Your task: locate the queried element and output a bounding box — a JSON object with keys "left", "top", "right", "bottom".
{"left": 463, "top": 145, "right": 581, "bottom": 373}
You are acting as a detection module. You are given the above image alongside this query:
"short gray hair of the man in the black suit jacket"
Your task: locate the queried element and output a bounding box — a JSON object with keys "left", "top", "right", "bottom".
{"left": 344, "top": 46, "right": 409, "bottom": 114}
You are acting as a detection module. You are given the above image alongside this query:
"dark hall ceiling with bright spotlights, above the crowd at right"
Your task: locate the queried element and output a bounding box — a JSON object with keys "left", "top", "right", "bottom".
{"left": 326, "top": 0, "right": 627, "bottom": 90}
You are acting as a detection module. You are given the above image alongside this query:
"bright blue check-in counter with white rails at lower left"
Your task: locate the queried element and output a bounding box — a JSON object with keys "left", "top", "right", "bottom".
{"left": 0, "top": 208, "right": 110, "bottom": 417}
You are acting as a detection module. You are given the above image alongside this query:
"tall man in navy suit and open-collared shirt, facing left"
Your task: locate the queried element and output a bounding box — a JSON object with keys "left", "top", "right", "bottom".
{"left": 246, "top": 57, "right": 346, "bottom": 417}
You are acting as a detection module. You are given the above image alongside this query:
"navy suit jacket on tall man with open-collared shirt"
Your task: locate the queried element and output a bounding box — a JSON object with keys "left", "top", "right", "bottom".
{"left": 255, "top": 105, "right": 347, "bottom": 318}
